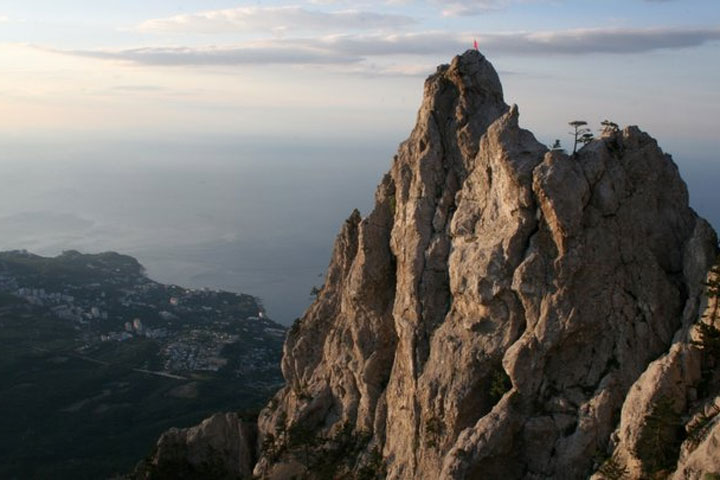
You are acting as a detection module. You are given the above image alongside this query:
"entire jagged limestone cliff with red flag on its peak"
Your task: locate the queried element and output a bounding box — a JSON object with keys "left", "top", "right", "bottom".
{"left": 138, "top": 51, "right": 720, "bottom": 479}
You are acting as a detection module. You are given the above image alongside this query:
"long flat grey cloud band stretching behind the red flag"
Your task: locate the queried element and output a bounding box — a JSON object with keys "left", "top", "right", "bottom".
{"left": 47, "top": 27, "right": 720, "bottom": 66}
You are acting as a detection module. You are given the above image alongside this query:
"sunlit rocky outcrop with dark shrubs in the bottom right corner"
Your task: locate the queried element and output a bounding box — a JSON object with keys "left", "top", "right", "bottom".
{"left": 595, "top": 267, "right": 720, "bottom": 480}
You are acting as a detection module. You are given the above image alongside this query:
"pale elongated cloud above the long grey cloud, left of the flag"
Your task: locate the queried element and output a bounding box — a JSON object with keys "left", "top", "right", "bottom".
{"left": 136, "top": 6, "right": 416, "bottom": 33}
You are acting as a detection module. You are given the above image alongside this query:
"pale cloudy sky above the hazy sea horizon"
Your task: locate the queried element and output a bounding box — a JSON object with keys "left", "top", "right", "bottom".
{"left": 0, "top": 0, "right": 720, "bottom": 151}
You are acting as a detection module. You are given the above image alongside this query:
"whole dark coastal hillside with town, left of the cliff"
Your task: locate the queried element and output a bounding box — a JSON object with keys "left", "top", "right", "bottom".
{"left": 0, "top": 251, "right": 286, "bottom": 478}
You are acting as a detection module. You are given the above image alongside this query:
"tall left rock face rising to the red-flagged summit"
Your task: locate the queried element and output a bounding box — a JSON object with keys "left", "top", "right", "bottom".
{"left": 256, "top": 52, "right": 508, "bottom": 473}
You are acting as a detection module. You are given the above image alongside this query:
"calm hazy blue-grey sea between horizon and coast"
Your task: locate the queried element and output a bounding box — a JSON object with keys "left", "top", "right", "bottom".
{"left": 0, "top": 133, "right": 720, "bottom": 324}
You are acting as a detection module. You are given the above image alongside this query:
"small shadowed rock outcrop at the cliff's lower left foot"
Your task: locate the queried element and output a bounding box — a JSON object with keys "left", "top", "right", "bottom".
{"left": 131, "top": 413, "right": 257, "bottom": 480}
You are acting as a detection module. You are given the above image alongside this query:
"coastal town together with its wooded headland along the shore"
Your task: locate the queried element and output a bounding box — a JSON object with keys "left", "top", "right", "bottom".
{"left": 0, "top": 251, "right": 285, "bottom": 381}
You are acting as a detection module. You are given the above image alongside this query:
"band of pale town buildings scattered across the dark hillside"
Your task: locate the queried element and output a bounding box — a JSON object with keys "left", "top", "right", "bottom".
{"left": 0, "top": 260, "right": 285, "bottom": 380}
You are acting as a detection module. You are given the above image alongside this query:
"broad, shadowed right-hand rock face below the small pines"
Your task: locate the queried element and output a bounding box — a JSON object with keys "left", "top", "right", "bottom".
{"left": 443, "top": 128, "right": 715, "bottom": 478}
